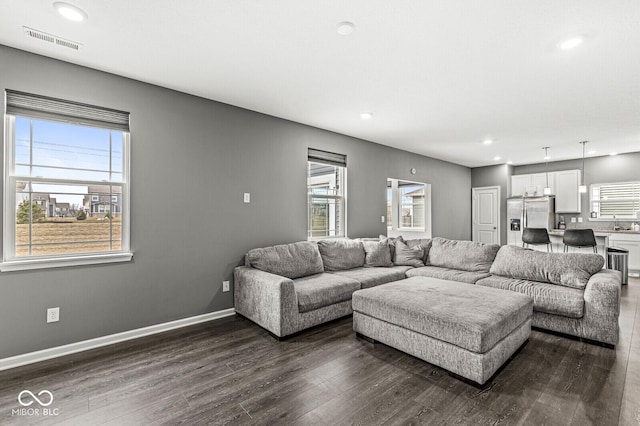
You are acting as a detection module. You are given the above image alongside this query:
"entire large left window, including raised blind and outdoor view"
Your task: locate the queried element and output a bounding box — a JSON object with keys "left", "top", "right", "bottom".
{"left": 0, "top": 90, "right": 132, "bottom": 271}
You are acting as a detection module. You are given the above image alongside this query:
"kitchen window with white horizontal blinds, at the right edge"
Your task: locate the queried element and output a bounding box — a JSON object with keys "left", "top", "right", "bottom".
{"left": 590, "top": 182, "right": 640, "bottom": 220}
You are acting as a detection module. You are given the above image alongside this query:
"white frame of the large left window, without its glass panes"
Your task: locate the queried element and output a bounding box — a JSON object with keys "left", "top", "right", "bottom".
{"left": 0, "top": 113, "right": 133, "bottom": 272}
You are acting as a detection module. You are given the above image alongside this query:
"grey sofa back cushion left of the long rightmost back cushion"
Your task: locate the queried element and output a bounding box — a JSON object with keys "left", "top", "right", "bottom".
{"left": 429, "top": 238, "right": 500, "bottom": 272}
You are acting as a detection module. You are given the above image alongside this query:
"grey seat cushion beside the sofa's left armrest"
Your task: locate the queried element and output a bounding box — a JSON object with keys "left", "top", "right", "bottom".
{"left": 293, "top": 273, "right": 360, "bottom": 313}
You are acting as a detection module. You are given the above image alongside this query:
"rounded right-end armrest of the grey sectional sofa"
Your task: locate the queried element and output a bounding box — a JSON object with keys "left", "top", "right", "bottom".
{"left": 583, "top": 269, "right": 622, "bottom": 345}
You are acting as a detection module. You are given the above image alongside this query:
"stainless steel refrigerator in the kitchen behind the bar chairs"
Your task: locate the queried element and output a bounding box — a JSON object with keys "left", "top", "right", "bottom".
{"left": 507, "top": 195, "right": 556, "bottom": 245}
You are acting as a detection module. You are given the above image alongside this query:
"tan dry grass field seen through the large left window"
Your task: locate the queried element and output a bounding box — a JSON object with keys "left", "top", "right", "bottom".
{"left": 16, "top": 217, "right": 122, "bottom": 257}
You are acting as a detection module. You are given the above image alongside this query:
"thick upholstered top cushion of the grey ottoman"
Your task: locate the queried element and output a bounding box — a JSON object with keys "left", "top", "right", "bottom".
{"left": 353, "top": 277, "right": 533, "bottom": 353}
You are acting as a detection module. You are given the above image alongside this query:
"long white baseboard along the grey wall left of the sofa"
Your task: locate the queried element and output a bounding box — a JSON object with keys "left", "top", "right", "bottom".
{"left": 0, "top": 308, "right": 236, "bottom": 371}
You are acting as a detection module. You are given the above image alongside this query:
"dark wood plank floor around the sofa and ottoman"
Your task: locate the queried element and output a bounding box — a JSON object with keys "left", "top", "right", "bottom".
{"left": 0, "top": 279, "right": 640, "bottom": 425}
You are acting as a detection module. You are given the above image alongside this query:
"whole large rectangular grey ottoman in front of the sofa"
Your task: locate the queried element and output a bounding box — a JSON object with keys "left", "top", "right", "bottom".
{"left": 353, "top": 277, "right": 533, "bottom": 386}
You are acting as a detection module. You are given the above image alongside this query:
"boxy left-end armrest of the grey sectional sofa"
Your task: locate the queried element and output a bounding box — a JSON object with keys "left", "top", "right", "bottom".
{"left": 233, "top": 266, "right": 298, "bottom": 337}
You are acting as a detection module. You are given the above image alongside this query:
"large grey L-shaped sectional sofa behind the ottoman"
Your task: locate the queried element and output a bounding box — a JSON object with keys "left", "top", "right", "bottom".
{"left": 234, "top": 236, "right": 621, "bottom": 346}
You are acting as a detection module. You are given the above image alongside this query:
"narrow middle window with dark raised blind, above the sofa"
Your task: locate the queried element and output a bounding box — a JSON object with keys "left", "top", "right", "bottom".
{"left": 307, "top": 148, "right": 347, "bottom": 239}
